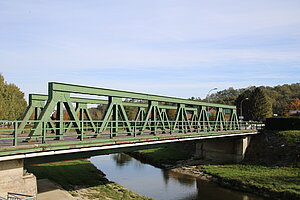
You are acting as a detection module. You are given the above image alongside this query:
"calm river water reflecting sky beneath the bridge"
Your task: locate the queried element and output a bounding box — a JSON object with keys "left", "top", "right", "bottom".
{"left": 91, "top": 154, "right": 263, "bottom": 200}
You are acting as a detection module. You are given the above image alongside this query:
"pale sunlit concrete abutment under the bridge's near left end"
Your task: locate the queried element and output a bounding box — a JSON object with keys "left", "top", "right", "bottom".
{"left": 0, "top": 159, "right": 37, "bottom": 197}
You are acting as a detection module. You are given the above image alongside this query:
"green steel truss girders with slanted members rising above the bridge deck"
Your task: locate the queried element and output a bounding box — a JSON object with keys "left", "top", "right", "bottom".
{"left": 24, "top": 82, "right": 238, "bottom": 140}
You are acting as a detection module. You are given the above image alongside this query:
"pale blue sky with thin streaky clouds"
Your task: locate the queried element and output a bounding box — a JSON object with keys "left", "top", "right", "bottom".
{"left": 0, "top": 0, "right": 300, "bottom": 101}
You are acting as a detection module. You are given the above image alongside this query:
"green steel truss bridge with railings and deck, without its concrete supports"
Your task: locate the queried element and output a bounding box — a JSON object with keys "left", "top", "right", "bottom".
{"left": 0, "top": 82, "right": 261, "bottom": 160}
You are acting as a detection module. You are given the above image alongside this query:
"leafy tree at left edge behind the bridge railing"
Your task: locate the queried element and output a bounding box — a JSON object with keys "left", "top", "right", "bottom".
{"left": 0, "top": 74, "right": 27, "bottom": 120}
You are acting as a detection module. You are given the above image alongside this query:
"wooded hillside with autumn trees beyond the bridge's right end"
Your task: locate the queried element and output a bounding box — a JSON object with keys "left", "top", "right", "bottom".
{"left": 191, "top": 83, "right": 300, "bottom": 120}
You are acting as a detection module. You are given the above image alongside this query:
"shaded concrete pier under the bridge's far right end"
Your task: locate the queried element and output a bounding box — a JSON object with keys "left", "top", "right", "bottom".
{"left": 195, "top": 136, "right": 251, "bottom": 163}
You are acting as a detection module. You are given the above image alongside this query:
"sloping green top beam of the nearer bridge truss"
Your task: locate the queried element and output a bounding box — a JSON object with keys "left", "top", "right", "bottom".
{"left": 49, "top": 82, "right": 236, "bottom": 109}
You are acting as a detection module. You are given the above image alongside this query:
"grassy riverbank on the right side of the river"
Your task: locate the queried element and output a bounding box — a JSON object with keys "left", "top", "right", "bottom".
{"left": 129, "top": 131, "right": 300, "bottom": 199}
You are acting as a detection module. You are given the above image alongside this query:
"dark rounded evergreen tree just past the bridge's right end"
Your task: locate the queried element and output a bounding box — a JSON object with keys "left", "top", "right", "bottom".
{"left": 249, "top": 88, "right": 273, "bottom": 121}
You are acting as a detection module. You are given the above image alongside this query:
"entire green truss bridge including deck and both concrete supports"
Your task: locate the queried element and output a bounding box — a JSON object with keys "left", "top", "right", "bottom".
{"left": 0, "top": 82, "right": 261, "bottom": 196}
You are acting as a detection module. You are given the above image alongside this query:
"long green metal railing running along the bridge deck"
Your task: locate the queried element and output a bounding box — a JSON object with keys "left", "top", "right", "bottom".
{"left": 0, "top": 120, "right": 263, "bottom": 147}
